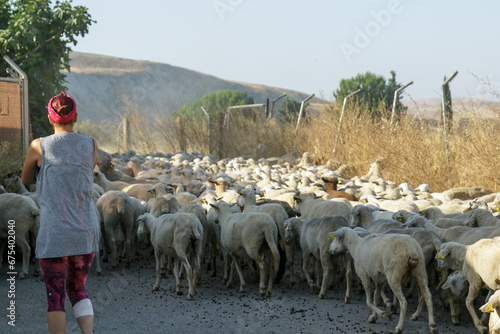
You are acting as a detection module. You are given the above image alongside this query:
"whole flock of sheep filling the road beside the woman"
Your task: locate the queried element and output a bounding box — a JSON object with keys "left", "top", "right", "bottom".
{"left": 0, "top": 151, "right": 500, "bottom": 333}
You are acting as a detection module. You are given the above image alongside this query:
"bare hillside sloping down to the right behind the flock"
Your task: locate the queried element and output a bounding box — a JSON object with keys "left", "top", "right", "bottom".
{"left": 66, "top": 52, "right": 328, "bottom": 123}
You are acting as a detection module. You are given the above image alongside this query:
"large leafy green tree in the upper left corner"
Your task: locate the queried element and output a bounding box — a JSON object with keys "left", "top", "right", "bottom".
{"left": 0, "top": 0, "right": 95, "bottom": 138}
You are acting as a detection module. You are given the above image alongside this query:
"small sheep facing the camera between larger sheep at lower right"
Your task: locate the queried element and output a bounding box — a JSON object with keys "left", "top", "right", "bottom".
{"left": 441, "top": 270, "right": 469, "bottom": 325}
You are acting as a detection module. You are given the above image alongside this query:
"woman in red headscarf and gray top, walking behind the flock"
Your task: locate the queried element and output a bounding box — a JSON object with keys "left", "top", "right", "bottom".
{"left": 22, "top": 93, "right": 100, "bottom": 334}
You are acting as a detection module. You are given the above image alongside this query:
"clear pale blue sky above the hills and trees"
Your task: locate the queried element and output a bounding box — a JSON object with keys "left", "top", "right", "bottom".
{"left": 72, "top": 0, "right": 500, "bottom": 101}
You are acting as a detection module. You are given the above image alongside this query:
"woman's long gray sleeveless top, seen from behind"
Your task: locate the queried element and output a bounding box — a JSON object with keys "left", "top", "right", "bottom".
{"left": 35, "top": 133, "right": 100, "bottom": 259}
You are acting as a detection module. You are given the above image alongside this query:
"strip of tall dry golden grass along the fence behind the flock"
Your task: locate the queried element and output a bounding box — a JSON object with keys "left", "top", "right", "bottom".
{"left": 76, "top": 99, "right": 500, "bottom": 192}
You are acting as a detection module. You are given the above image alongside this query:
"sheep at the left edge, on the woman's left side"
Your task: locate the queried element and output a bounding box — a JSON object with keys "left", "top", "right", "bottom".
{"left": 0, "top": 193, "right": 40, "bottom": 279}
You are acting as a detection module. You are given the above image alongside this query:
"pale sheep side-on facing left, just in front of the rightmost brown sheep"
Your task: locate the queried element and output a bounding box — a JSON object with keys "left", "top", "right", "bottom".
{"left": 293, "top": 192, "right": 351, "bottom": 221}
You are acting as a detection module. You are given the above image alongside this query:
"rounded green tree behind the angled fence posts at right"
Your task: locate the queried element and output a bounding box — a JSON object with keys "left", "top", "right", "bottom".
{"left": 333, "top": 71, "right": 406, "bottom": 117}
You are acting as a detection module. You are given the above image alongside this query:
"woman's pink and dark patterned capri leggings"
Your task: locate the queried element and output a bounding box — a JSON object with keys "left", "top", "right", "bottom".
{"left": 40, "top": 253, "right": 94, "bottom": 312}
